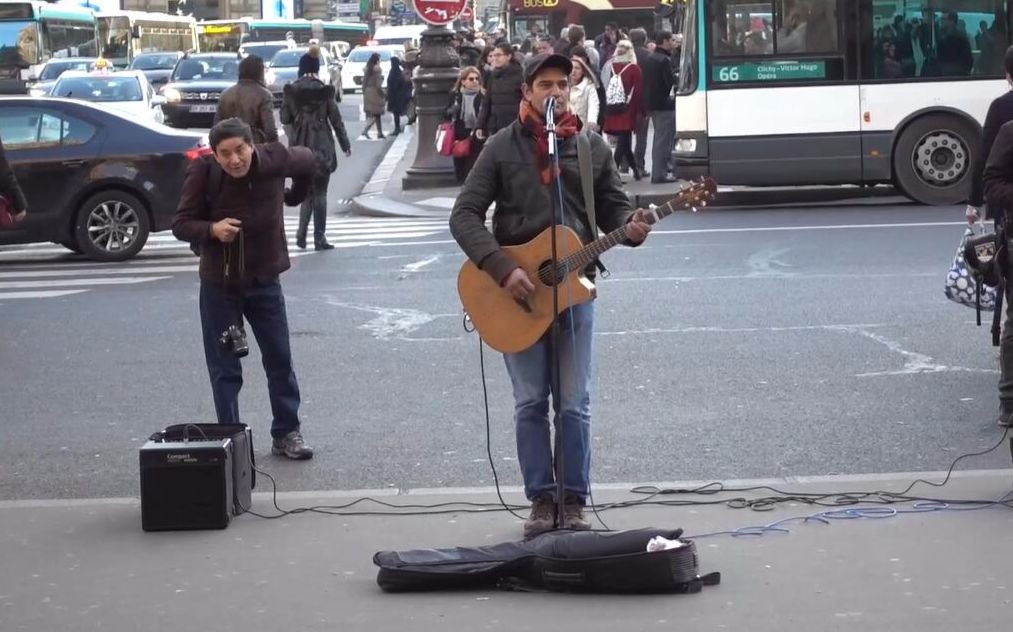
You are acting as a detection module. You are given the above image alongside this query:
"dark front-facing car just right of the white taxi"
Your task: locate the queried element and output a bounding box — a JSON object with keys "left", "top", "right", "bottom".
{"left": 161, "top": 53, "right": 240, "bottom": 128}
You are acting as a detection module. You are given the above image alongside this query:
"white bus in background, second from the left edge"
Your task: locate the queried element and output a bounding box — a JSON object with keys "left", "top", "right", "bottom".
{"left": 95, "top": 11, "right": 198, "bottom": 68}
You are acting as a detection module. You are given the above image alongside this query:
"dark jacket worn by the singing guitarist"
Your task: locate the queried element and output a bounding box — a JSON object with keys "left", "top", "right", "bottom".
{"left": 450, "top": 120, "right": 633, "bottom": 284}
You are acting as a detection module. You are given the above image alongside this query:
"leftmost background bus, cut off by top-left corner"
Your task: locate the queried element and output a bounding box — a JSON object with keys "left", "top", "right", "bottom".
{"left": 0, "top": 1, "right": 97, "bottom": 94}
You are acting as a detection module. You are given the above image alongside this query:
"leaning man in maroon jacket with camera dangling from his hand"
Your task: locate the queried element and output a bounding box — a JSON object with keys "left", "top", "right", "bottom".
{"left": 172, "top": 119, "right": 315, "bottom": 459}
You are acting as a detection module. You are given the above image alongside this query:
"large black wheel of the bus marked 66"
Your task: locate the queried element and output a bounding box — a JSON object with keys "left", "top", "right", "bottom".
{"left": 893, "top": 114, "right": 981, "bottom": 205}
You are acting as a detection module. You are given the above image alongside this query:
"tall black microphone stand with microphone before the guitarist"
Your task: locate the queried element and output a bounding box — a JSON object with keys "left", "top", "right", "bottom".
{"left": 545, "top": 96, "right": 566, "bottom": 528}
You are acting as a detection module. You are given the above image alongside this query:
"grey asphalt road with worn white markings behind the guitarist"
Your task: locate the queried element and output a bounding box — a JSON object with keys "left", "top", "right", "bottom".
{"left": 0, "top": 192, "right": 1010, "bottom": 499}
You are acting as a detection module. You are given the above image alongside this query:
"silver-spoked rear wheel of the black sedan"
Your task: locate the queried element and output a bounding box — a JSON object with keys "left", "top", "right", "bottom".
{"left": 74, "top": 189, "right": 151, "bottom": 261}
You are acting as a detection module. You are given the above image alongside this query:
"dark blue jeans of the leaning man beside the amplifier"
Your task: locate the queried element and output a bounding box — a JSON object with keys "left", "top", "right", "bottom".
{"left": 201, "top": 277, "right": 300, "bottom": 438}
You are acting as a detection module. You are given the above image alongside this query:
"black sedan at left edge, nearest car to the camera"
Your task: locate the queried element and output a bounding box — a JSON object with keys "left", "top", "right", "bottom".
{"left": 0, "top": 97, "right": 211, "bottom": 261}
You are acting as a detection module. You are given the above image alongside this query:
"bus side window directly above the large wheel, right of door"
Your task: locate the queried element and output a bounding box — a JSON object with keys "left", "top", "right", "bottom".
{"left": 864, "top": 0, "right": 1010, "bottom": 80}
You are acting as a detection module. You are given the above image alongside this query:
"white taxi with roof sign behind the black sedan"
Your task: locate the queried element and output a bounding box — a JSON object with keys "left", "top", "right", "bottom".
{"left": 51, "top": 70, "right": 165, "bottom": 123}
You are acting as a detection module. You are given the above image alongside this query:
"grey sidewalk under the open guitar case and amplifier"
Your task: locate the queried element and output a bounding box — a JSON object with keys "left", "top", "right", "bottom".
{"left": 0, "top": 465, "right": 1013, "bottom": 632}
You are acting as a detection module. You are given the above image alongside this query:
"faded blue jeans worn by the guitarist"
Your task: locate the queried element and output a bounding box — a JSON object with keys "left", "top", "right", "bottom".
{"left": 503, "top": 302, "right": 595, "bottom": 502}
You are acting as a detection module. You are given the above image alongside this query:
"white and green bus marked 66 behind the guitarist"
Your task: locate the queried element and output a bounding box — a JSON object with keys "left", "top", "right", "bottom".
{"left": 674, "top": 0, "right": 1011, "bottom": 205}
